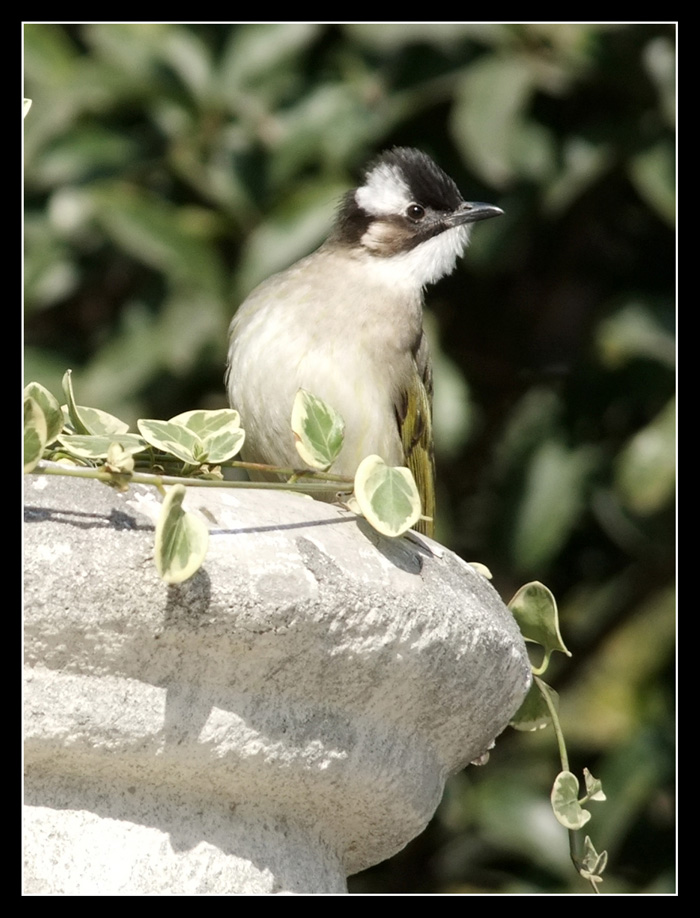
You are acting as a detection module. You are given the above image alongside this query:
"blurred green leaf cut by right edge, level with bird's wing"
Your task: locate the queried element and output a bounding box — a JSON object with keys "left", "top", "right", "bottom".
{"left": 615, "top": 398, "right": 676, "bottom": 515}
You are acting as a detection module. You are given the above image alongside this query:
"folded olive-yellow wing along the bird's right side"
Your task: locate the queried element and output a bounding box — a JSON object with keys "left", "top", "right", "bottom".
{"left": 396, "top": 332, "right": 435, "bottom": 536}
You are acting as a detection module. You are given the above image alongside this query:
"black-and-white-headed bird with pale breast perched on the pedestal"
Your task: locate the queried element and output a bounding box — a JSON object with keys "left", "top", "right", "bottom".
{"left": 225, "top": 147, "right": 503, "bottom": 535}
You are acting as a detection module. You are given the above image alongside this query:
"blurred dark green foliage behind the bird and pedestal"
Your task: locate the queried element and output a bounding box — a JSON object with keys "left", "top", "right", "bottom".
{"left": 24, "top": 23, "right": 675, "bottom": 893}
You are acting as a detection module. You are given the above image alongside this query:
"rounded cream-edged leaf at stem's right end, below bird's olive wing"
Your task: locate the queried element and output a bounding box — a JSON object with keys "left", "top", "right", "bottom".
{"left": 355, "top": 456, "right": 421, "bottom": 536}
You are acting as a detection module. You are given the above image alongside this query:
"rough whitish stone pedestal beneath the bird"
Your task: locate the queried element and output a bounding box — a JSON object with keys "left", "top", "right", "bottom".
{"left": 25, "top": 475, "right": 530, "bottom": 895}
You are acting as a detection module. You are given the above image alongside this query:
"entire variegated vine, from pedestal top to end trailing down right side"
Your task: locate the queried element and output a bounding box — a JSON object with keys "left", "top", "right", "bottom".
{"left": 24, "top": 370, "right": 607, "bottom": 892}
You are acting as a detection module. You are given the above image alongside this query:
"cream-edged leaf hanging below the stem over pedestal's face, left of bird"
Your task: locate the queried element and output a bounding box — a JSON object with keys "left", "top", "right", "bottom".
{"left": 155, "top": 485, "right": 209, "bottom": 583}
